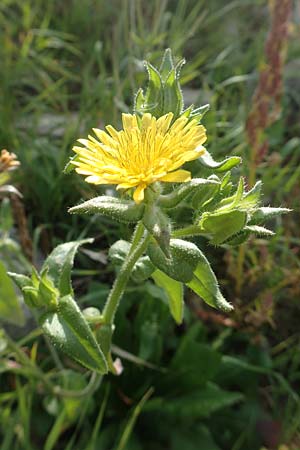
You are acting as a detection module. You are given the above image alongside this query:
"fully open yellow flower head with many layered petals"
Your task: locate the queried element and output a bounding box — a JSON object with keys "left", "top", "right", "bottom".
{"left": 72, "top": 113, "right": 206, "bottom": 203}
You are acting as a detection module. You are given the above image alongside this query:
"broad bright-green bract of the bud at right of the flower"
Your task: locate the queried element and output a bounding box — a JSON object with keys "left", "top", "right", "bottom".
{"left": 199, "top": 210, "right": 247, "bottom": 245}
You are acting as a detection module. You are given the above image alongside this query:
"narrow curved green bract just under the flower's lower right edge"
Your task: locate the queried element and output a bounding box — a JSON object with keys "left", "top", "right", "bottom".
{"left": 158, "top": 178, "right": 220, "bottom": 209}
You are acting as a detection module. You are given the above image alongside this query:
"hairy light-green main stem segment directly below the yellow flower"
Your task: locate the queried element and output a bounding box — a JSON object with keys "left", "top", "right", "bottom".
{"left": 103, "top": 222, "right": 150, "bottom": 325}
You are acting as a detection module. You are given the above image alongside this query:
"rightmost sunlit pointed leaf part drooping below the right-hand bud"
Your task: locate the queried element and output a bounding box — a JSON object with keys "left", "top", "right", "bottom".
{"left": 186, "top": 250, "right": 233, "bottom": 312}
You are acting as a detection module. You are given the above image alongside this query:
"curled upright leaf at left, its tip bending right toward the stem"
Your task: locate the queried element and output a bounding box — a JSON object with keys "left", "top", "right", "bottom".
{"left": 41, "top": 239, "right": 93, "bottom": 297}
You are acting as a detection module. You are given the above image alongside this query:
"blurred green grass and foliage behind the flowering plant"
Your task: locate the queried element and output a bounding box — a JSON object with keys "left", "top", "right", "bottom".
{"left": 0, "top": 0, "right": 300, "bottom": 450}
